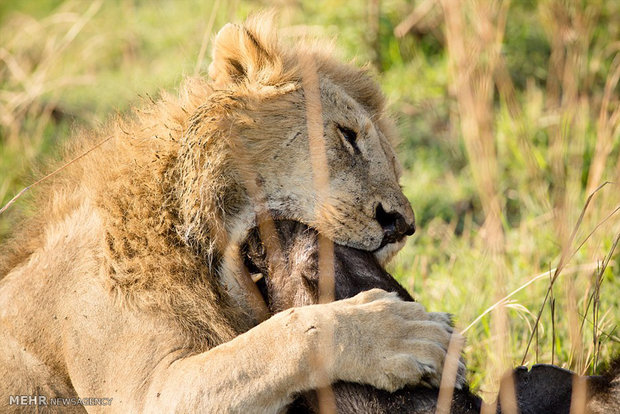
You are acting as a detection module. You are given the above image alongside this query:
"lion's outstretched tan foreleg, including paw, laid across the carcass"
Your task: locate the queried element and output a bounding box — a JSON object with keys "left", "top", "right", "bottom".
{"left": 144, "top": 289, "right": 458, "bottom": 412}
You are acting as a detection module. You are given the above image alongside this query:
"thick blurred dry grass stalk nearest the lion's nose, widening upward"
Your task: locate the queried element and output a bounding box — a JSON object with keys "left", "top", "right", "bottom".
{"left": 441, "top": 0, "right": 516, "bottom": 402}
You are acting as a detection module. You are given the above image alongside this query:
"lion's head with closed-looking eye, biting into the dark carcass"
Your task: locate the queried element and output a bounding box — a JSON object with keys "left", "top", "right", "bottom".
{"left": 174, "top": 16, "right": 414, "bottom": 272}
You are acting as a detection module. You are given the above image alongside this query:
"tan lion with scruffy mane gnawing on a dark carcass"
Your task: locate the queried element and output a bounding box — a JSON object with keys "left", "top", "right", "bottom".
{"left": 0, "top": 15, "right": 452, "bottom": 413}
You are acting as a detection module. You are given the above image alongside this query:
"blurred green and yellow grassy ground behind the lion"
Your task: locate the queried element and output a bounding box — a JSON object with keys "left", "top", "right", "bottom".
{"left": 0, "top": 0, "right": 620, "bottom": 398}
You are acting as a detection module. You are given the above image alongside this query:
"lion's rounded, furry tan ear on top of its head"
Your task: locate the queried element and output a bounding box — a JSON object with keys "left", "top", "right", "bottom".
{"left": 209, "top": 18, "right": 282, "bottom": 87}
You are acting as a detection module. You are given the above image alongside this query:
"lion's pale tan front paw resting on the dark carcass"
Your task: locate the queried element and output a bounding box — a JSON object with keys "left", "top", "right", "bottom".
{"left": 332, "top": 289, "right": 464, "bottom": 391}
